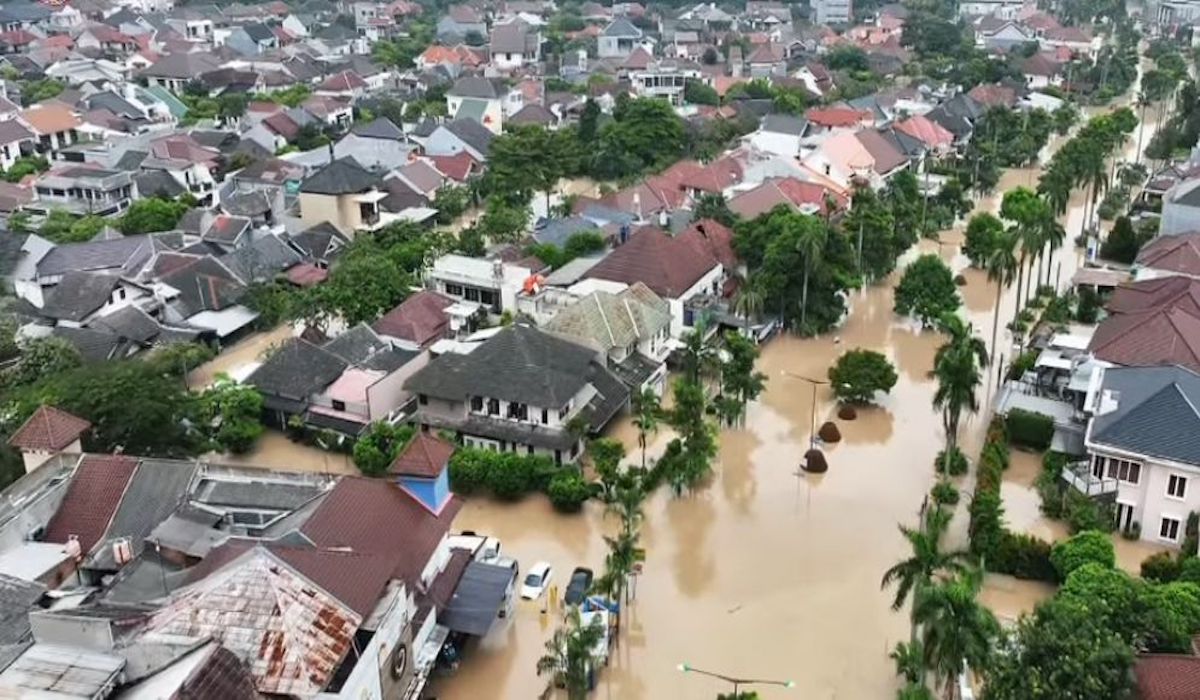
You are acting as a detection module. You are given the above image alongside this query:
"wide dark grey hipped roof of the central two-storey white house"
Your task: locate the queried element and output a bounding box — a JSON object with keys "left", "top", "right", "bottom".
{"left": 404, "top": 324, "right": 628, "bottom": 408}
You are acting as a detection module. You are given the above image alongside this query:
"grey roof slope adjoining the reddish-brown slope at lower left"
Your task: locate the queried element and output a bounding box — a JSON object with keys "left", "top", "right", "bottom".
{"left": 90, "top": 460, "right": 196, "bottom": 570}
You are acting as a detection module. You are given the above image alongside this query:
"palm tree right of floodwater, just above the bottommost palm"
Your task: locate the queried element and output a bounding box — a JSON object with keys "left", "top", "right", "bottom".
{"left": 880, "top": 508, "right": 971, "bottom": 648}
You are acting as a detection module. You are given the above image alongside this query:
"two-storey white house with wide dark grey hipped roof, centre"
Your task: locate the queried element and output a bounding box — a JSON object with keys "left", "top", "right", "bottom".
{"left": 406, "top": 323, "right": 629, "bottom": 463}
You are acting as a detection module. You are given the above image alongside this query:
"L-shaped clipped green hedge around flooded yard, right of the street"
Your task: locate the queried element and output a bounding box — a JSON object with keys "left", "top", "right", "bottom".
{"left": 968, "top": 418, "right": 1058, "bottom": 581}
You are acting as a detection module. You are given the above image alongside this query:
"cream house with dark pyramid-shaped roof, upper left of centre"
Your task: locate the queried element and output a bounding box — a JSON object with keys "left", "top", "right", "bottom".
{"left": 300, "top": 158, "right": 388, "bottom": 238}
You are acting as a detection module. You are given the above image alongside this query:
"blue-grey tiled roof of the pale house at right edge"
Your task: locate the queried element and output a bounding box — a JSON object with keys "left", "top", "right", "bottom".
{"left": 1091, "top": 365, "right": 1200, "bottom": 466}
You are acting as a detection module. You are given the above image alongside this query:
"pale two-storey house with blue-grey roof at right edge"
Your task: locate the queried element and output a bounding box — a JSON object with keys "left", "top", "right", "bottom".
{"left": 1085, "top": 365, "right": 1200, "bottom": 546}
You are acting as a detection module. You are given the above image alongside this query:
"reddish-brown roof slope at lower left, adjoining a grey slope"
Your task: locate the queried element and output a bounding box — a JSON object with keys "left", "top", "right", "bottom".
{"left": 46, "top": 455, "right": 138, "bottom": 552}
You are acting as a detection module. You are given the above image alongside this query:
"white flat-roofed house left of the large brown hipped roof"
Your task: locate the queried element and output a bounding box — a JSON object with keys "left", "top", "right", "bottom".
{"left": 425, "top": 253, "right": 534, "bottom": 317}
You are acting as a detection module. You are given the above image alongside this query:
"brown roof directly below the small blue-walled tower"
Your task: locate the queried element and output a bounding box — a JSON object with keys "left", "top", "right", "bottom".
{"left": 301, "top": 477, "right": 462, "bottom": 584}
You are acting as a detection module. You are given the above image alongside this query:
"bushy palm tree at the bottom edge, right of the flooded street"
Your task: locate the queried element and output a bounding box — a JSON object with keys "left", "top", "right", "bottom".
{"left": 913, "top": 568, "right": 1000, "bottom": 700}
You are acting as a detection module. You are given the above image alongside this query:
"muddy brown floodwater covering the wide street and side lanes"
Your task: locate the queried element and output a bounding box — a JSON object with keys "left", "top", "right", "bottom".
{"left": 431, "top": 88, "right": 1171, "bottom": 700}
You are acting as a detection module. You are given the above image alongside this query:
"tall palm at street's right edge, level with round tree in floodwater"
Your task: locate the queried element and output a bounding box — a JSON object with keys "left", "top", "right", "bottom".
{"left": 934, "top": 313, "right": 988, "bottom": 460}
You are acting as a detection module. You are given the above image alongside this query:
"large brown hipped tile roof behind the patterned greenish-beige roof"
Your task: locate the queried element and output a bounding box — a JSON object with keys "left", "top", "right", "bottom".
{"left": 587, "top": 226, "right": 719, "bottom": 299}
